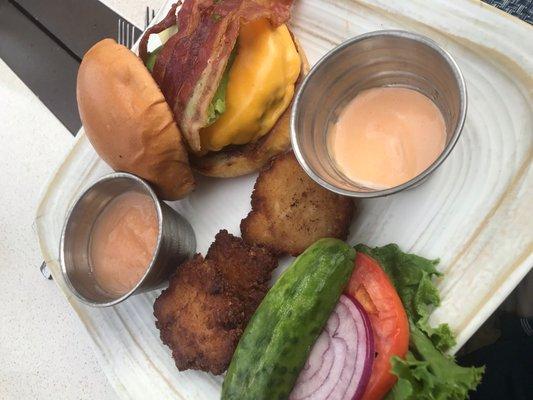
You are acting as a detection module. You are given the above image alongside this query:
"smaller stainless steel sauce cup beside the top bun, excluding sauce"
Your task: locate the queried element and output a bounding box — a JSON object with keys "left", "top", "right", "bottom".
{"left": 60, "top": 172, "right": 196, "bottom": 307}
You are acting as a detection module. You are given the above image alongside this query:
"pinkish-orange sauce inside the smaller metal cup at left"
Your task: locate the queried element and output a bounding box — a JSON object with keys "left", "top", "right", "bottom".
{"left": 90, "top": 192, "right": 158, "bottom": 295}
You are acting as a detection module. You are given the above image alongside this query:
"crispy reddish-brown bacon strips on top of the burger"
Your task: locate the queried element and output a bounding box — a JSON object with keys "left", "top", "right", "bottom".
{"left": 140, "top": 0, "right": 292, "bottom": 152}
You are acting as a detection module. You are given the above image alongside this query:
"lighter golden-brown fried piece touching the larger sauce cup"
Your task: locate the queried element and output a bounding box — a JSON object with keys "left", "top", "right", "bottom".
{"left": 241, "top": 152, "right": 354, "bottom": 256}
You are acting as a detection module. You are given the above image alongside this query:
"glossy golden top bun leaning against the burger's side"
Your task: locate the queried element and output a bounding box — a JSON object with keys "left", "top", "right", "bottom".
{"left": 77, "top": 39, "right": 195, "bottom": 200}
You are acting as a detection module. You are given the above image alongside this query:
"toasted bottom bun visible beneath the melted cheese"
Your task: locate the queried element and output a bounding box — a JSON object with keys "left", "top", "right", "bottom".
{"left": 191, "top": 32, "right": 309, "bottom": 178}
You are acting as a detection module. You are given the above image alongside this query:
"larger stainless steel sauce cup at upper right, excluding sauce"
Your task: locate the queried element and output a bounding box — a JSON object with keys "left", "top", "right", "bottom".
{"left": 291, "top": 30, "right": 467, "bottom": 197}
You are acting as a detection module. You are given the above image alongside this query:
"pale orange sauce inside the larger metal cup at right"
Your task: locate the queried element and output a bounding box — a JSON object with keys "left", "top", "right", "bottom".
{"left": 328, "top": 87, "right": 446, "bottom": 189}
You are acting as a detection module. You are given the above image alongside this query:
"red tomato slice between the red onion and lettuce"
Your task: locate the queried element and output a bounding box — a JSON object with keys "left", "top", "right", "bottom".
{"left": 345, "top": 253, "right": 409, "bottom": 400}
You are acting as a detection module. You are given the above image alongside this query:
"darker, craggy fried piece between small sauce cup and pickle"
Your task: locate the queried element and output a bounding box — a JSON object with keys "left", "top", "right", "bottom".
{"left": 154, "top": 230, "right": 277, "bottom": 375}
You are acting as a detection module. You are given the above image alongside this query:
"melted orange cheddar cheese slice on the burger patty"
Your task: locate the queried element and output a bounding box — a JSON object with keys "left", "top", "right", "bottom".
{"left": 200, "top": 19, "right": 301, "bottom": 151}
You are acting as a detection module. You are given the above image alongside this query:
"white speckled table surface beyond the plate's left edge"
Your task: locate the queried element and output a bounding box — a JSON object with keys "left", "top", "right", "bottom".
{"left": 0, "top": 0, "right": 163, "bottom": 400}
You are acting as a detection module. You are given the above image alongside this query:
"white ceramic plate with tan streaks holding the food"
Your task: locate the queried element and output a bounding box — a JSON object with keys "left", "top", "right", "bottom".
{"left": 36, "top": 0, "right": 533, "bottom": 399}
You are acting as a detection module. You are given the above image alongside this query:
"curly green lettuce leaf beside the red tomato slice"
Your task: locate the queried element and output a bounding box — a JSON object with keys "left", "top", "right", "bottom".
{"left": 356, "top": 244, "right": 484, "bottom": 400}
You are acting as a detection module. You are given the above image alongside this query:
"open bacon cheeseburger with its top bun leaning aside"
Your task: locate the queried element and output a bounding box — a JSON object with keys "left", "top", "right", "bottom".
{"left": 77, "top": 0, "right": 308, "bottom": 200}
